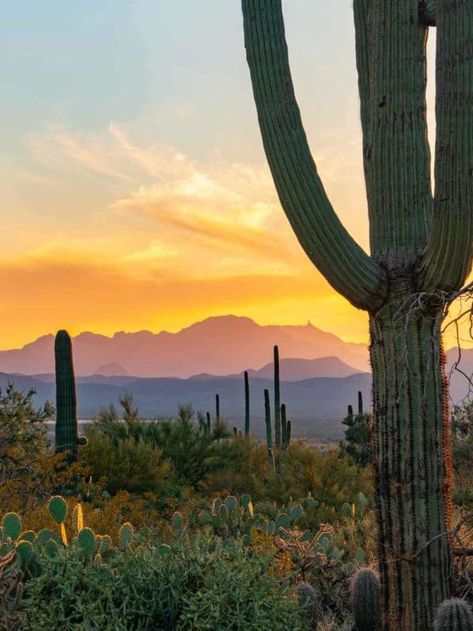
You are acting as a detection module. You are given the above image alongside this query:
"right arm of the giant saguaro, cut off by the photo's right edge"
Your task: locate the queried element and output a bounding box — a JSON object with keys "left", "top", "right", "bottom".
{"left": 424, "top": 0, "right": 473, "bottom": 291}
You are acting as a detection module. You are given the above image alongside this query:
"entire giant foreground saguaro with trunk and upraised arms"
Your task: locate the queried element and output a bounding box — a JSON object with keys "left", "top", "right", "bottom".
{"left": 242, "top": 0, "right": 473, "bottom": 631}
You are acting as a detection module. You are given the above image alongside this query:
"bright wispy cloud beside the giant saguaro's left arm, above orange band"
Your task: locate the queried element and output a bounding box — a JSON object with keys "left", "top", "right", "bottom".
{"left": 27, "top": 123, "right": 304, "bottom": 274}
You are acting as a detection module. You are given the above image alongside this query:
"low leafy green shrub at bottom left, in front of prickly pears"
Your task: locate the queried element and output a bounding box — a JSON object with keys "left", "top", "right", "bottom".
{"left": 23, "top": 537, "right": 302, "bottom": 631}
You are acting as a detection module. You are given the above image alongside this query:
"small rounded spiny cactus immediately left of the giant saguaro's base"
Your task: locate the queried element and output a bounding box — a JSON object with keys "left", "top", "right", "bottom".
{"left": 350, "top": 568, "right": 381, "bottom": 631}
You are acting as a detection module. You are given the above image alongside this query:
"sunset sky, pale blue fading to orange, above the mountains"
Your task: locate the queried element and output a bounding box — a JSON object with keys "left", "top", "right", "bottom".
{"left": 0, "top": 0, "right": 446, "bottom": 348}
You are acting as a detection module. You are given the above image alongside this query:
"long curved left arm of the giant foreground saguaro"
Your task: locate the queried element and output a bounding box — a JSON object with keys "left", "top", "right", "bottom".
{"left": 242, "top": 0, "right": 384, "bottom": 309}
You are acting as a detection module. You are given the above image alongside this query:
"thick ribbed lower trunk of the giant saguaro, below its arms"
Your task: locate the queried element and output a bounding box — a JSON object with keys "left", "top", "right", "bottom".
{"left": 370, "top": 306, "right": 451, "bottom": 629}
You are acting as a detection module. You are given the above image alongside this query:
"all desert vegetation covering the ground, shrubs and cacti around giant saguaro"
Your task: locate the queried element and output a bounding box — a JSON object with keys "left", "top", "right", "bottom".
{"left": 0, "top": 331, "right": 473, "bottom": 631}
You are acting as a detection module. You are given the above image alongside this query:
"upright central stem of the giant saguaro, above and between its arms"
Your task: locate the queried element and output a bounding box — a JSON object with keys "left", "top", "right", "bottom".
{"left": 365, "top": 0, "right": 433, "bottom": 264}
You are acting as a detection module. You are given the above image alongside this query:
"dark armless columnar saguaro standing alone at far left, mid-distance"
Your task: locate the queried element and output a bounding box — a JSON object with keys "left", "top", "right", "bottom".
{"left": 54, "top": 331, "right": 87, "bottom": 460}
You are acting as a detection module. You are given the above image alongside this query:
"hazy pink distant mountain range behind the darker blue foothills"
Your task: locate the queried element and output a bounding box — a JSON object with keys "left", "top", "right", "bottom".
{"left": 0, "top": 316, "right": 369, "bottom": 378}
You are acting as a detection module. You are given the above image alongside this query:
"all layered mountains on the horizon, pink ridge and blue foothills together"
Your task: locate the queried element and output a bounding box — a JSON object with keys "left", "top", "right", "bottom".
{"left": 0, "top": 316, "right": 473, "bottom": 440}
